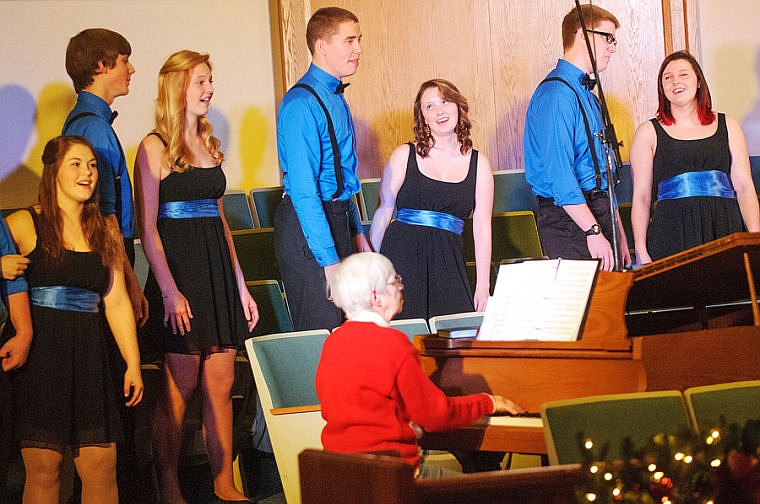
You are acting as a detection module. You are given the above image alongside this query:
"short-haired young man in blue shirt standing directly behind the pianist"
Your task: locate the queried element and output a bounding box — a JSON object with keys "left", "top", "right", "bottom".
{"left": 274, "top": 7, "right": 370, "bottom": 330}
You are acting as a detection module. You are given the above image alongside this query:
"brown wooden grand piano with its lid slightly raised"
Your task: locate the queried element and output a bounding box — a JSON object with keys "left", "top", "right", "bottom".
{"left": 415, "top": 233, "right": 760, "bottom": 454}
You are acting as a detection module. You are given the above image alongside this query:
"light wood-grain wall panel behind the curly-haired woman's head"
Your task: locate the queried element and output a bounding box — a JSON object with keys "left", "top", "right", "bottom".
{"left": 312, "top": 0, "right": 494, "bottom": 178}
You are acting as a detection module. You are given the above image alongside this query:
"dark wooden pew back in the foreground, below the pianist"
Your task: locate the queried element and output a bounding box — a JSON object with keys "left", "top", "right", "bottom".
{"left": 299, "top": 450, "right": 581, "bottom": 504}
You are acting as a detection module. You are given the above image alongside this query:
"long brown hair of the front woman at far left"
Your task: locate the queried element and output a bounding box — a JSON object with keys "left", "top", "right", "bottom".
{"left": 37, "top": 136, "right": 123, "bottom": 267}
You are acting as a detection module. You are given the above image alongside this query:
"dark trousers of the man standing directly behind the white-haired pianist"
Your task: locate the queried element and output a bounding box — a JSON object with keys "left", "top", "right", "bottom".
{"left": 274, "top": 196, "right": 354, "bottom": 331}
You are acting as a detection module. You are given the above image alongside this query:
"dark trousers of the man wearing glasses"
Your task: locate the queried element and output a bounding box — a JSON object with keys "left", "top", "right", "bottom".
{"left": 537, "top": 191, "right": 612, "bottom": 259}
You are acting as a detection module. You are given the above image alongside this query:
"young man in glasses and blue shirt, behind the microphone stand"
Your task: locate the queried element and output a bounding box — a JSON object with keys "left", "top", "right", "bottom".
{"left": 524, "top": 5, "right": 631, "bottom": 271}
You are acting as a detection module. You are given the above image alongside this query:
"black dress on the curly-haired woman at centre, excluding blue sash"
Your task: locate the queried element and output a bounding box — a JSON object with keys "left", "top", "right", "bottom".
{"left": 380, "top": 144, "right": 478, "bottom": 320}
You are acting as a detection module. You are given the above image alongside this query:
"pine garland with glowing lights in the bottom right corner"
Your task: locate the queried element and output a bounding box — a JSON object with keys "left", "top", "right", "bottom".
{"left": 576, "top": 418, "right": 760, "bottom": 504}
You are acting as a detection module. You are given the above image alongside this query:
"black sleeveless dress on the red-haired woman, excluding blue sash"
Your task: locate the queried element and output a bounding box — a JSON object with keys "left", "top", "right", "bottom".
{"left": 647, "top": 114, "right": 744, "bottom": 261}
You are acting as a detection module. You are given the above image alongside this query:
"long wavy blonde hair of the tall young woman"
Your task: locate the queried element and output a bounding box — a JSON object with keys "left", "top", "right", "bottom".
{"left": 155, "top": 50, "right": 224, "bottom": 173}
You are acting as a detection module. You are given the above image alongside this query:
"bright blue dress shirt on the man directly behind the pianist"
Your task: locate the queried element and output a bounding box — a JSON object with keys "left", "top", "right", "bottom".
{"left": 277, "top": 64, "right": 363, "bottom": 266}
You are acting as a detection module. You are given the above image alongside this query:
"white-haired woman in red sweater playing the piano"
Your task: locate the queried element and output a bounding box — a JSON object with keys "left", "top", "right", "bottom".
{"left": 316, "top": 252, "right": 525, "bottom": 476}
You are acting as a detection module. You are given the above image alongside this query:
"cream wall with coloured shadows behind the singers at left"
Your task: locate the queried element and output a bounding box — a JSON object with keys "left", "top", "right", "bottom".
{"left": 0, "top": 0, "right": 279, "bottom": 207}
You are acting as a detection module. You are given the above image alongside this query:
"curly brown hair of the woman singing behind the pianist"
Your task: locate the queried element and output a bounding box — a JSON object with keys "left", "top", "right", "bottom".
{"left": 414, "top": 79, "right": 472, "bottom": 157}
